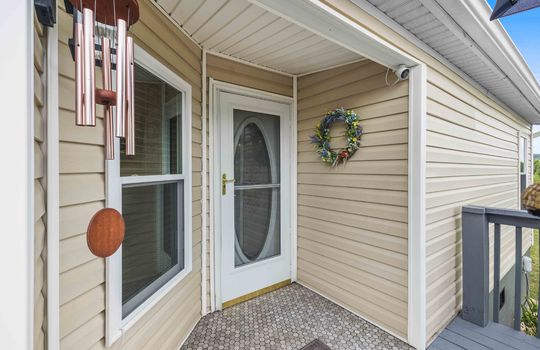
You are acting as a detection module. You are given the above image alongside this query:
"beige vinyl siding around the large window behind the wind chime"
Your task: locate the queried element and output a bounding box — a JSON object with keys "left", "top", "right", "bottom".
{"left": 58, "top": 1, "right": 202, "bottom": 350}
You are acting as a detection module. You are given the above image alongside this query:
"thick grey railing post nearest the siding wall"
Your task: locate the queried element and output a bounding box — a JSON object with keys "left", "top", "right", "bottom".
{"left": 461, "top": 206, "right": 489, "bottom": 327}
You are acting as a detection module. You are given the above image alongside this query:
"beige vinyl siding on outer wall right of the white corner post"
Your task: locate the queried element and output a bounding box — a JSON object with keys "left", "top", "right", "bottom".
{"left": 322, "top": 0, "right": 530, "bottom": 340}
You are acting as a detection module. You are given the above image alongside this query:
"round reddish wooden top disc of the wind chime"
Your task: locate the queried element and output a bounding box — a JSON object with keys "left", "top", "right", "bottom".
{"left": 69, "top": 0, "right": 139, "bottom": 26}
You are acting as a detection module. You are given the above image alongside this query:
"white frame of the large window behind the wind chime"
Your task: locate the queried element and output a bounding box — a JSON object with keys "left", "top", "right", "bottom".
{"left": 105, "top": 46, "right": 193, "bottom": 346}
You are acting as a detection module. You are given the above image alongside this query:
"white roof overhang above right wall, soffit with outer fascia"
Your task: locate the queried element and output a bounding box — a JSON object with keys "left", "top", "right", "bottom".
{"left": 362, "top": 0, "right": 540, "bottom": 123}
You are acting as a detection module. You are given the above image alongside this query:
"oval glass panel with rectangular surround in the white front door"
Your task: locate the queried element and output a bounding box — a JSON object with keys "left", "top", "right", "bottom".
{"left": 234, "top": 110, "right": 281, "bottom": 267}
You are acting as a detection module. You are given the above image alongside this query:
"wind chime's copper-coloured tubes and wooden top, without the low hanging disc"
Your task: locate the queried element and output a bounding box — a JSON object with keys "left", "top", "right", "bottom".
{"left": 69, "top": 0, "right": 139, "bottom": 160}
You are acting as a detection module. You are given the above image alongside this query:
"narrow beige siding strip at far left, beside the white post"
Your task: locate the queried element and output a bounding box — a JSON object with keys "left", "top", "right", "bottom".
{"left": 34, "top": 10, "right": 47, "bottom": 350}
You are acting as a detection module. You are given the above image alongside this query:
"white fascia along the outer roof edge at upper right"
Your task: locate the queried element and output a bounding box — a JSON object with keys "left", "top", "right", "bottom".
{"left": 432, "top": 0, "right": 540, "bottom": 123}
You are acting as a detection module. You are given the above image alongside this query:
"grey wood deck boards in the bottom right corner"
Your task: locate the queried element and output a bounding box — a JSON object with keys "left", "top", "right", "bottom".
{"left": 428, "top": 316, "right": 540, "bottom": 350}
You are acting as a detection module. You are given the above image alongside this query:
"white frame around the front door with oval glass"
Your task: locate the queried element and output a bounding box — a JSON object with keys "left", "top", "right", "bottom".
{"left": 209, "top": 79, "right": 297, "bottom": 311}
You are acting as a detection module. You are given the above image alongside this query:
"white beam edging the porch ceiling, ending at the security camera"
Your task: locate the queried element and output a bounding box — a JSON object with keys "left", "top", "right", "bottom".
{"left": 248, "top": 0, "right": 419, "bottom": 69}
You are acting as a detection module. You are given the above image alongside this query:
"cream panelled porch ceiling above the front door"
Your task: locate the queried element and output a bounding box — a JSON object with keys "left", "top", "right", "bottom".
{"left": 156, "top": 0, "right": 363, "bottom": 74}
